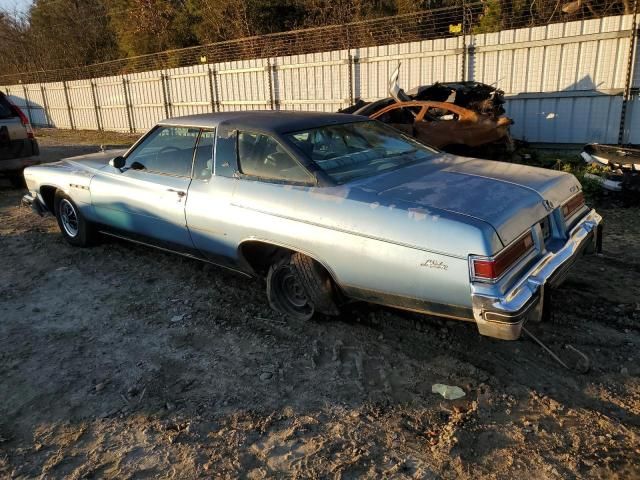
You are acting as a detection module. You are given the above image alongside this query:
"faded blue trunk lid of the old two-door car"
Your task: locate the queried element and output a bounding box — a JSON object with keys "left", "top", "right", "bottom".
{"left": 352, "top": 155, "right": 580, "bottom": 245}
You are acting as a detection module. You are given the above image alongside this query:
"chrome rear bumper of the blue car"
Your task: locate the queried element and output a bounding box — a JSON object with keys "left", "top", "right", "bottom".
{"left": 471, "top": 210, "right": 602, "bottom": 340}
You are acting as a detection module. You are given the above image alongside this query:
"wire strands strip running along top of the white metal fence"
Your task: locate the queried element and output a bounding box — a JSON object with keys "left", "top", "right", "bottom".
{"left": 0, "top": 0, "right": 633, "bottom": 85}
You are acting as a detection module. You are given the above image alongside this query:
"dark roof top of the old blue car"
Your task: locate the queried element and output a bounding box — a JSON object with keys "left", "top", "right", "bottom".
{"left": 158, "top": 110, "right": 369, "bottom": 134}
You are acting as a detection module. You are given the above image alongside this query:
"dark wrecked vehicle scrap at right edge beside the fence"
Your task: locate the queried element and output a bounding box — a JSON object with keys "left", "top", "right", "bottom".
{"left": 581, "top": 143, "right": 640, "bottom": 202}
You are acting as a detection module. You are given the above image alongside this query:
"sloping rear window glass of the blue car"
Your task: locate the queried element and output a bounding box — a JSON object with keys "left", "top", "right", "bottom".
{"left": 286, "top": 121, "right": 437, "bottom": 184}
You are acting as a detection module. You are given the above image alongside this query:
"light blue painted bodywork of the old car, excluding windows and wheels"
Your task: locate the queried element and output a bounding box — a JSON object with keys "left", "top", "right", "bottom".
{"left": 25, "top": 112, "right": 597, "bottom": 340}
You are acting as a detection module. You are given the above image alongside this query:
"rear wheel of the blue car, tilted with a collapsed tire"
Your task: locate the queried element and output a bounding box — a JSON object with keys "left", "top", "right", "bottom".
{"left": 267, "top": 253, "right": 338, "bottom": 320}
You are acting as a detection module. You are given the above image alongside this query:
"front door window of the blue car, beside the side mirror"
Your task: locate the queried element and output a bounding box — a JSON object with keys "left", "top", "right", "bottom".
{"left": 126, "top": 127, "right": 200, "bottom": 177}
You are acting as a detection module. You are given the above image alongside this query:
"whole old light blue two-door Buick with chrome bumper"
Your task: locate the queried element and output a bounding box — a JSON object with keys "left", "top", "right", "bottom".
{"left": 23, "top": 111, "right": 601, "bottom": 339}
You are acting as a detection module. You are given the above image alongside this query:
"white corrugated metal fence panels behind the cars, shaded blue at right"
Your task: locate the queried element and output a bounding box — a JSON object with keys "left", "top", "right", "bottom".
{"left": 2, "top": 15, "right": 640, "bottom": 143}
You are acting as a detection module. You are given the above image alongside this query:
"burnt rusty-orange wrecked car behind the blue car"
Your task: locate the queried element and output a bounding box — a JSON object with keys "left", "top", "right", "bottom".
{"left": 340, "top": 67, "right": 514, "bottom": 159}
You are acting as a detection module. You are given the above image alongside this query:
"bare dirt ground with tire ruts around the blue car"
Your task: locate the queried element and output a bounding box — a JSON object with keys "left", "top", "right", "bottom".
{"left": 0, "top": 132, "right": 640, "bottom": 479}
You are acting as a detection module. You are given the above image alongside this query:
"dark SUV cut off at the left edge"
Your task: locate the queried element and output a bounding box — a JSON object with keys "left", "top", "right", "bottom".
{"left": 0, "top": 92, "right": 40, "bottom": 187}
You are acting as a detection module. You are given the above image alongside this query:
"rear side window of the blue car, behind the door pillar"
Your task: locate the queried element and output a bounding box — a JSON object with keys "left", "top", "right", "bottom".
{"left": 238, "top": 132, "right": 313, "bottom": 183}
